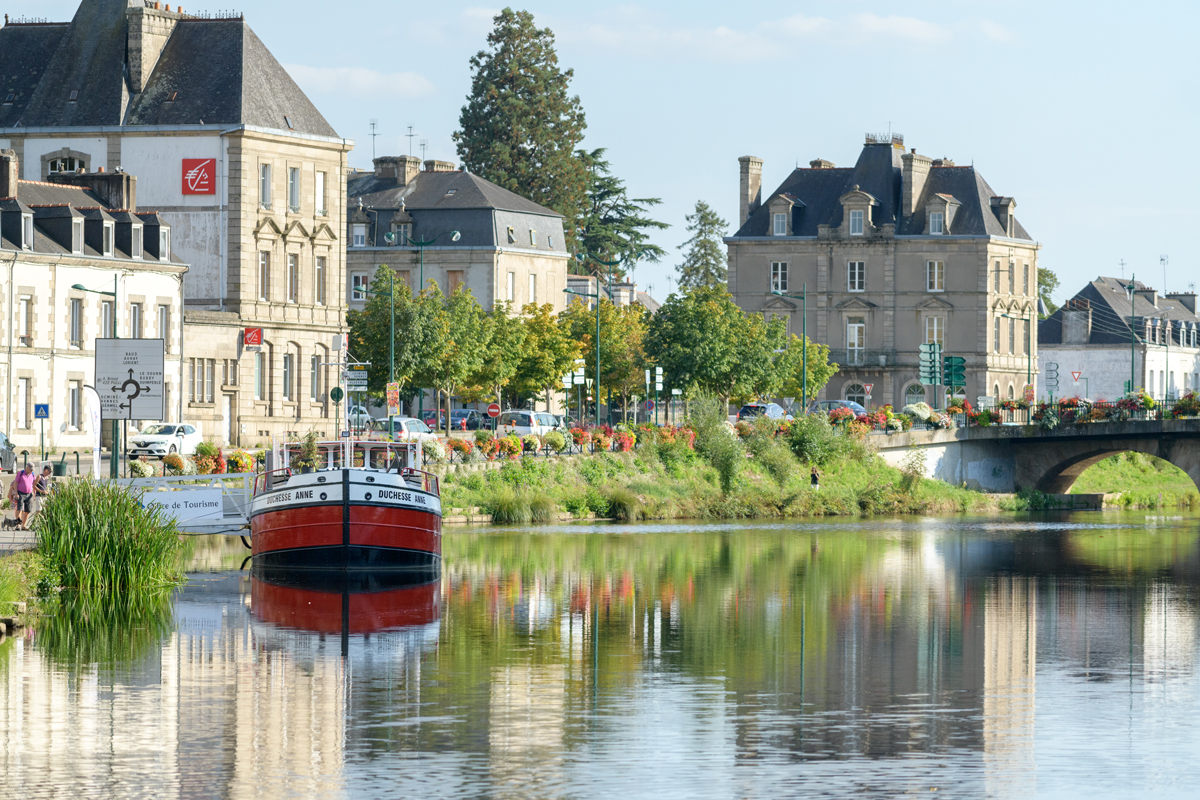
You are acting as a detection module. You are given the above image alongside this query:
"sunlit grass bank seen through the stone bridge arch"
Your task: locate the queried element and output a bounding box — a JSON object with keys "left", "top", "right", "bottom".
{"left": 1070, "top": 452, "right": 1200, "bottom": 509}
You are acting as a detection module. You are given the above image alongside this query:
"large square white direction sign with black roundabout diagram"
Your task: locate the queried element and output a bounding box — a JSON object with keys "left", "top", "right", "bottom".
{"left": 96, "top": 338, "right": 166, "bottom": 420}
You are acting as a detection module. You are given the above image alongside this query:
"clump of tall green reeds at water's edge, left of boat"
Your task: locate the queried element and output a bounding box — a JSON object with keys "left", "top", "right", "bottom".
{"left": 34, "top": 481, "right": 182, "bottom": 593}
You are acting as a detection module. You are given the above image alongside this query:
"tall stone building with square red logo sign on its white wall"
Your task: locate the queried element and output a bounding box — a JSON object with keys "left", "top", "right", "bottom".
{"left": 0, "top": 0, "right": 352, "bottom": 445}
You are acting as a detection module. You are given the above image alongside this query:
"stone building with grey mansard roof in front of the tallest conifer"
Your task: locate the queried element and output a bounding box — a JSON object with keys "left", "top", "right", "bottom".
{"left": 346, "top": 156, "right": 570, "bottom": 313}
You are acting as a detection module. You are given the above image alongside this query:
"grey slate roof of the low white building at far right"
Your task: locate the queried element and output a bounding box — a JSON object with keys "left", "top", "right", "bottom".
{"left": 1038, "top": 277, "right": 1200, "bottom": 345}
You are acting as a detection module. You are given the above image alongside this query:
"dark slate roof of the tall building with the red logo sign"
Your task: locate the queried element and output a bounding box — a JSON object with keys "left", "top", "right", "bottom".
{"left": 0, "top": 0, "right": 337, "bottom": 137}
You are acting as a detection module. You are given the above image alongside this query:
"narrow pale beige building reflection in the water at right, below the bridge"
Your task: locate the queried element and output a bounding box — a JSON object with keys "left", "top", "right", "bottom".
{"left": 983, "top": 575, "right": 1038, "bottom": 796}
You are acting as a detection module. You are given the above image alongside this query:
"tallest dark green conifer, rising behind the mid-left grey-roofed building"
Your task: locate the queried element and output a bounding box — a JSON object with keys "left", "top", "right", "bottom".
{"left": 454, "top": 8, "right": 588, "bottom": 246}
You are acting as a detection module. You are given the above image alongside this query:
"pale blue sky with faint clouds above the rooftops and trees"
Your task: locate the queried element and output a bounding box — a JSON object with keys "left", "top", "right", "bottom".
{"left": 9, "top": 0, "right": 1200, "bottom": 302}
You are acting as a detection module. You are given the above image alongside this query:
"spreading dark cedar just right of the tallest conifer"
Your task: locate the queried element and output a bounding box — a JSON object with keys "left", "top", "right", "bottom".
{"left": 571, "top": 148, "right": 670, "bottom": 278}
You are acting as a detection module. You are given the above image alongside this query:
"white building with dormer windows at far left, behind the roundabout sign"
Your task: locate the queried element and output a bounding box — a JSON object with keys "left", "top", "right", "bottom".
{"left": 0, "top": 150, "right": 187, "bottom": 455}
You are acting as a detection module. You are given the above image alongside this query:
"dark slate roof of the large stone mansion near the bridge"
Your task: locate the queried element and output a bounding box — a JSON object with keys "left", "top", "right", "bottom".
{"left": 734, "top": 143, "right": 1032, "bottom": 241}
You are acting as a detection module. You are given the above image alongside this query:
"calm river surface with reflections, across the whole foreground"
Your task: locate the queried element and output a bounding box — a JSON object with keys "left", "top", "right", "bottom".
{"left": 0, "top": 513, "right": 1200, "bottom": 800}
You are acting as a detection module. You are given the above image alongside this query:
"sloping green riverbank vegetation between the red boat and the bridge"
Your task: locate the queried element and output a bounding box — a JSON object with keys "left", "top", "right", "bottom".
{"left": 443, "top": 399, "right": 1003, "bottom": 523}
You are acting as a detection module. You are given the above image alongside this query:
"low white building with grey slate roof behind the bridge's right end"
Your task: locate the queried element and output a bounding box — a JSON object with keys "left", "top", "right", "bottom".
{"left": 1038, "top": 277, "right": 1200, "bottom": 399}
